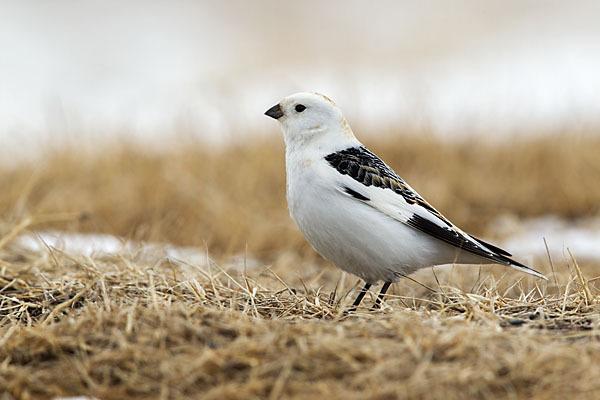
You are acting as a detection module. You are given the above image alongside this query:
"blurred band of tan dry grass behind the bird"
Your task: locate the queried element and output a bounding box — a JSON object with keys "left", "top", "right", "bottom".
{"left": 0, "top": 135, "right": 600, "bottom": 255}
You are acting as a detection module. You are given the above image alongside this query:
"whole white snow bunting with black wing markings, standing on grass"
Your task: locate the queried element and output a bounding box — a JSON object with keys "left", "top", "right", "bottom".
{"left": 265, "top": 93, "right": 547, "bottom": 309}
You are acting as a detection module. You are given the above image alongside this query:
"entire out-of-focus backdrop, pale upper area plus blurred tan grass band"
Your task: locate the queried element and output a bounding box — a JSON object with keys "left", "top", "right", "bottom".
{"left": 0, "top": 0, "right": 600, "bottom": 266}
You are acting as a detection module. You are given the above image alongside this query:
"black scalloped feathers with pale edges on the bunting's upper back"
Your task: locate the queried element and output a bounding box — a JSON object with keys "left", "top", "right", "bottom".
{"left": 325, "top": 146, "right": 452, "bottom": 227}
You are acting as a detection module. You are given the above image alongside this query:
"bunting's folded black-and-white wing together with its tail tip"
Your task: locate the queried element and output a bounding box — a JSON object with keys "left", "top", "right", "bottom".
{"left": 325, "top": 146, "right": 547, "bottom": 279}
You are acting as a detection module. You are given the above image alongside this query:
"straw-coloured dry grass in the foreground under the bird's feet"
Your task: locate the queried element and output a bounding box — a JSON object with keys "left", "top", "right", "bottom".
{"left": 0, "top": 230, "right": 600, "bottom": 399}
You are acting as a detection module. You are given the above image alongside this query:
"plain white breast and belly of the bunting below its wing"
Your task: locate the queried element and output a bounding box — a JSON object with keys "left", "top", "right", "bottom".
{"left": 287, "top": 158, "right": 458, "bottom": 283}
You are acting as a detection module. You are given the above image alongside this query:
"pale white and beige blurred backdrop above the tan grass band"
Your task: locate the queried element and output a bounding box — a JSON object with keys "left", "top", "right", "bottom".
{"left": 0, "top": 0, "right": 600, "bottom": 149}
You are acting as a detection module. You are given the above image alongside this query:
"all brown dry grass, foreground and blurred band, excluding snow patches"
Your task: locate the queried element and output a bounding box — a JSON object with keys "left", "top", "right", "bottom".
{"left": 0, "top": 137, "right": 600, "bottom": 399}
